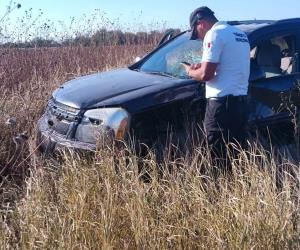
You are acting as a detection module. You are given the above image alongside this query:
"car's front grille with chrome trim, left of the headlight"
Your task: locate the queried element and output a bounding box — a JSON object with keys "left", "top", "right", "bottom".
{"left": 46, "top": 99, "right": 80, "bottom": 136}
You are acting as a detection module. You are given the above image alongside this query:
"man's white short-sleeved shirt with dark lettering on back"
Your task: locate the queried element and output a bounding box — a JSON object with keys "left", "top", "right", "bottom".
{"left": 202, "top": 22, "right": 250, "bottom": 98}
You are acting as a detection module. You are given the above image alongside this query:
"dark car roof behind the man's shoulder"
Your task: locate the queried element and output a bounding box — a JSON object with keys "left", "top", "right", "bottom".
{"left": 227, "top": 18, "right": 300, "bottom": 35}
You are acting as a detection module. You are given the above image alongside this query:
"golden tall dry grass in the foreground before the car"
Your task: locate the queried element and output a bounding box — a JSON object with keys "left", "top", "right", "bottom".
{"left": 0, "top": 148, "right": 300, "bottom": 249}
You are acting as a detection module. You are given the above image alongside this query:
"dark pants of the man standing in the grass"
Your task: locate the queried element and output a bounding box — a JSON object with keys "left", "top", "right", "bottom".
{"left": 204, "top": 95, "right": 248, "bottom": 170}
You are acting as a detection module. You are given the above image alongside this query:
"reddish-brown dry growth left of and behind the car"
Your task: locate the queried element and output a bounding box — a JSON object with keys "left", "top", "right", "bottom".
{"left": 0, "top": 45, "right": 151, "bottom": 218}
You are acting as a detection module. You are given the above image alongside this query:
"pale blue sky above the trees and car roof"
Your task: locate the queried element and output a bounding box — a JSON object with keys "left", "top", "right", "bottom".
{"left": 0, "top": 0, "right": 300, "bottom": 32}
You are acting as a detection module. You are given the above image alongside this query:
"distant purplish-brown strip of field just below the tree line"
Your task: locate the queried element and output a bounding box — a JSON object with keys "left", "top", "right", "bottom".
{"left": 0, "top": 44, "right": 153, "bottom": 91}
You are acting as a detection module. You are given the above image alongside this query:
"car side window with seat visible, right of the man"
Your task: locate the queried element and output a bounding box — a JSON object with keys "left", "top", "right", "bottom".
{"left": 251, "top": 35, "right": 298, "bottom": 78}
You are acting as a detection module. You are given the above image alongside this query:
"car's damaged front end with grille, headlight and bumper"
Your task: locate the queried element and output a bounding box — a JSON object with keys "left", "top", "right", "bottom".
{"left": 37, "top": 99, "right": 130, "bottom": 153}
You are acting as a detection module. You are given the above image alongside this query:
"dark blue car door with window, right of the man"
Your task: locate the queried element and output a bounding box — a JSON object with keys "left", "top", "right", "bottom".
{"left": 249, "top": 29, "right": 300, "bottom": 135}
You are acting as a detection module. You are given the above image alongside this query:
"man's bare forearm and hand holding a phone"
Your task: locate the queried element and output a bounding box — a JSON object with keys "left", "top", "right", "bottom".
{"left": 185, "top": 62, "right": 218, "bottom": 81}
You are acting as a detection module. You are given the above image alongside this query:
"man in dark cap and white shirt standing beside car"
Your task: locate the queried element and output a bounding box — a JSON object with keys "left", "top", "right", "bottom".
{"left": 185, "top": 7, "right": 250, "bottom": 171}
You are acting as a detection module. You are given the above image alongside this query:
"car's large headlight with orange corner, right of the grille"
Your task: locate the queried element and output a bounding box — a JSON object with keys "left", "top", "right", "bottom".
{"left": 75, "top": 108, "right": 130, "bottom": 143}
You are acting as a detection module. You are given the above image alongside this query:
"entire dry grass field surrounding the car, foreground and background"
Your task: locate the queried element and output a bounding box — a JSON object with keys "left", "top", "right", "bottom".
{"left": 0, "top": 44, "right": 300, "bottom": 249}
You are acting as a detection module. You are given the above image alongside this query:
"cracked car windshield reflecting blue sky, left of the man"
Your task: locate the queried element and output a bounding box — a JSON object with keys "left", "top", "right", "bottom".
{"left": 140, "top": 32, "right": 202, "bottom": 78}
